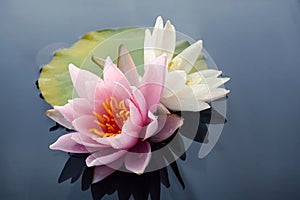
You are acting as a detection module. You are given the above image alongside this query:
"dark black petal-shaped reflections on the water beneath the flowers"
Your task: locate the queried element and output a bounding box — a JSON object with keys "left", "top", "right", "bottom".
{"left": 54, "top": 109, "right": 226, "bottom": 200}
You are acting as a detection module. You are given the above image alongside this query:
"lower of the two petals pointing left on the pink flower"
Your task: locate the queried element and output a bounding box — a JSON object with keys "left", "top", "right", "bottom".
{"left": 50, "top": 133, "right": 96, "bottom": 153}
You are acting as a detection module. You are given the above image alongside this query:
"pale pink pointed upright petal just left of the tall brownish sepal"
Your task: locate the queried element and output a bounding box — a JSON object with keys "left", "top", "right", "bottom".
{"left": 103, "top": 57, "right": 130, "bottom": 93}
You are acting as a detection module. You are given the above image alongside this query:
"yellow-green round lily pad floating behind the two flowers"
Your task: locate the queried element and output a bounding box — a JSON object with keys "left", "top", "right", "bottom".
{"left": 38, "top": 28, "right": 207, "bottom": 106}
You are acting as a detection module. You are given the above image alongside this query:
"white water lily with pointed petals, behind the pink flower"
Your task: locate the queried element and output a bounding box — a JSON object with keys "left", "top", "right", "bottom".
{"left": 144, "top": 16, "right": 229, "bottom": 111}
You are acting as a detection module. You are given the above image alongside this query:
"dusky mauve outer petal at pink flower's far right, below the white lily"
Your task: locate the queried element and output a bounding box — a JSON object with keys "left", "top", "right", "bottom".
{"left": 148, "top": 114, "right": 183, "bottom": 143}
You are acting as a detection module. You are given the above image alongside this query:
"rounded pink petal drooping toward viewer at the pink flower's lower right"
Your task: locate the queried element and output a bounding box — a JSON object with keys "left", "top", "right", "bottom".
{"left": 125, "top": 141, "right": 151, "bottom": 174}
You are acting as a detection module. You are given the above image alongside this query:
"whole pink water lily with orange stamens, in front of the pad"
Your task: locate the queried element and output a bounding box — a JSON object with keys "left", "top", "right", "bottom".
{"left": 46, "top": 52, "right": 183, "bottom": 183}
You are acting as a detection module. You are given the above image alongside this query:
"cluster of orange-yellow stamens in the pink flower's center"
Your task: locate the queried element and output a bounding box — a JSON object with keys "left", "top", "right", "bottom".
{"left": 89, "top": 97, "right": 129, "bottom": 137}
